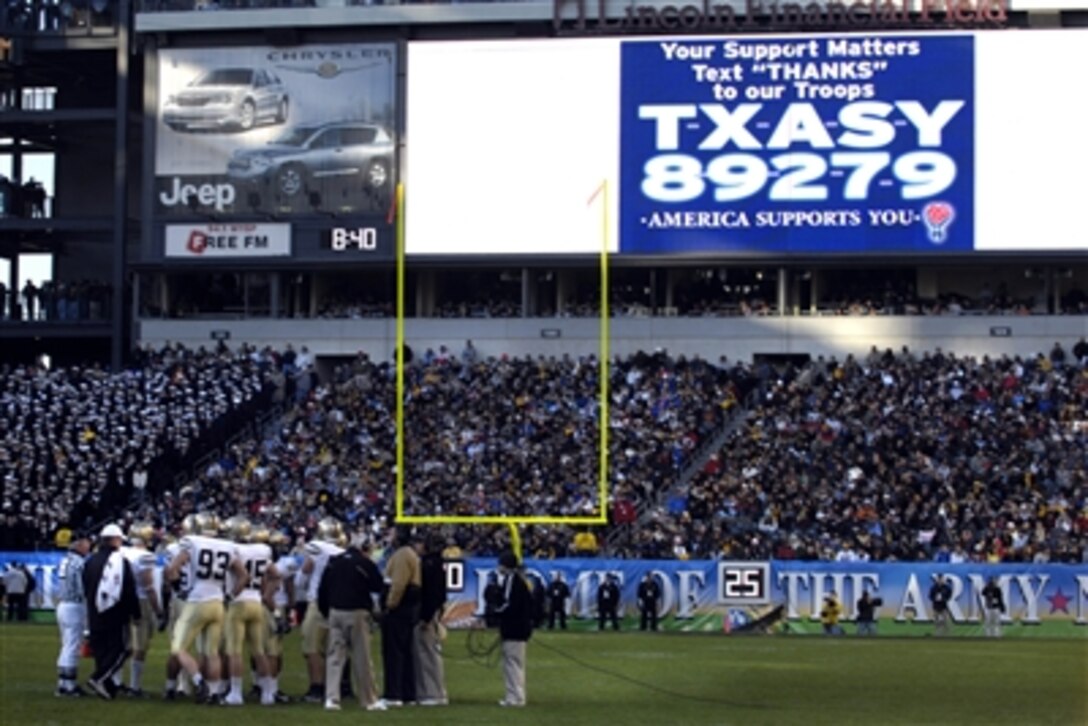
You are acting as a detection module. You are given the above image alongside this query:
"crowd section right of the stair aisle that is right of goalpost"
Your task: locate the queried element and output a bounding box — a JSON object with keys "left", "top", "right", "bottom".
{"left": 627, "top": 339, "right": 1088, "bottom": 562}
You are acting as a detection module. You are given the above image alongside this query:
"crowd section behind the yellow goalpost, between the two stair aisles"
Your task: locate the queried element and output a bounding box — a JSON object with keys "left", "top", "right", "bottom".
{"left": 110, "top": 343, "right": 751, "bottom": 554}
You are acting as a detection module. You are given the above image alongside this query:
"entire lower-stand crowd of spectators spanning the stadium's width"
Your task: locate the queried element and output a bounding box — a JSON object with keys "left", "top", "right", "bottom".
{"left": 0, "top": 340, "right": 1088, "bottom": 561}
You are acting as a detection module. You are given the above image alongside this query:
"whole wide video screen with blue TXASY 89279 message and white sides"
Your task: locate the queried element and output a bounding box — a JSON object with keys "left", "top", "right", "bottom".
{"left": 406, "top": 29, "right": 1088, "bottom": 256}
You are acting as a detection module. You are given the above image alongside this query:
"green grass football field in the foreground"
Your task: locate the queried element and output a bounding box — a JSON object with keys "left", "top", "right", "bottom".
{"left": 0, "top": 624, "right": 1088, "bottom": 726}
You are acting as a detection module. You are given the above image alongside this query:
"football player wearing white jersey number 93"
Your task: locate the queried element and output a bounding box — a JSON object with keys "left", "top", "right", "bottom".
{"left": 166, "top": 513, "right": 249, "bottom": 704}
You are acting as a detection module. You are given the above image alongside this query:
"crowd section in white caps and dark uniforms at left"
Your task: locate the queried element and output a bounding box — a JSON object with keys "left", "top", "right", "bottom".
{"left": 0, "top": 346, "right": 273, "bottom": 550}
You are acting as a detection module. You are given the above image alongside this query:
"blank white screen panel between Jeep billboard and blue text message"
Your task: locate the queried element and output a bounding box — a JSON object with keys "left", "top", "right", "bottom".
{"left": 405, "top": 40, "right": 619, "bottom": 255}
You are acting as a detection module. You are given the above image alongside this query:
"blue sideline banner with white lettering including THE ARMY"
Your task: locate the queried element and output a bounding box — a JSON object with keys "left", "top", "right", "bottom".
{"left": 6, "top": 552, "right": 1088, "bottom": 638}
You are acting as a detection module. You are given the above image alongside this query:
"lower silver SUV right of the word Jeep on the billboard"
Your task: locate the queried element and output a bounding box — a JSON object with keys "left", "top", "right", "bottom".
{"left": 226, "top": 122, "right": 393, "bottom": 198}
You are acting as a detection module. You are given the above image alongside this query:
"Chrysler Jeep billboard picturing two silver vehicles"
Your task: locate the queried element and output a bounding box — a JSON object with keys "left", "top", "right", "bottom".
{"left": 154, "top": 44, "right": 396, "bottom": 221}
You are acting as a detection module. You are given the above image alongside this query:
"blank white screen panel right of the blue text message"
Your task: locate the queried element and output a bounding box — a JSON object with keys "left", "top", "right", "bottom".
{"left": 975, "top": 30, "right": 1088, "bottom": 251}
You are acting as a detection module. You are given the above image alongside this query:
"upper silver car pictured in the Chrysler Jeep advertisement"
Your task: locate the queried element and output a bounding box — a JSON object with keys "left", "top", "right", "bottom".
{"left": 162, "top": 67, "right": 290, "bottom": 131}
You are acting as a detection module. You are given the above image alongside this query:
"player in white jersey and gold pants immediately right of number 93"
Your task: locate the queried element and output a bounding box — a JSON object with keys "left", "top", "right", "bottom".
{"left": 224, "top": 516, "right": 280, "bottom": 705}
